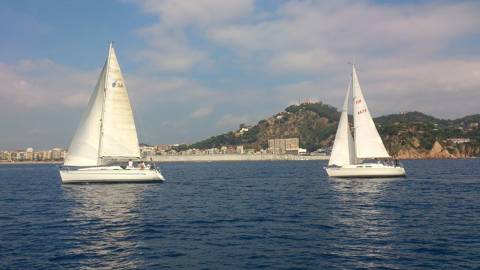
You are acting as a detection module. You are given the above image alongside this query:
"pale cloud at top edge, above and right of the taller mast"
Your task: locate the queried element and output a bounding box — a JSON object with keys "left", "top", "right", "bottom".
{"left": 131, "top": 0, "right": 253, "bottom": 72}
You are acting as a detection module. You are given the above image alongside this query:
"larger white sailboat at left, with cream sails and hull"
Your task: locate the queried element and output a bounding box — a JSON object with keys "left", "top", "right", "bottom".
{"left": 60, "top": 43, "right": 165, "bottom": 183}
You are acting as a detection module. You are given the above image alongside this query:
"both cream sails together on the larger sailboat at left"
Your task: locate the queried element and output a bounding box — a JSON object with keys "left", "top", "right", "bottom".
{"left": 65, "top": 43, "right": 140, "bottom": 166}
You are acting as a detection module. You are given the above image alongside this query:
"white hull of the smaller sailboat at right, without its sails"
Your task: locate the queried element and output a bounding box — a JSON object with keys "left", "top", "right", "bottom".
{"left": 325, "top": 163, "right": 405, "bottom": 177}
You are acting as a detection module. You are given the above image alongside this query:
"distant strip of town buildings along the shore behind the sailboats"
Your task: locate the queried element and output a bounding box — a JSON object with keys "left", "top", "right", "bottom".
{"left": 0, "top": 138, "right": 328, "bottom": 162}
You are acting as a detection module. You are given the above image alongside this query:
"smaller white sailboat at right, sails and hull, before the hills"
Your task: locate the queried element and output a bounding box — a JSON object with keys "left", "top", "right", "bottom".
{"left": 326, "top": 65, "right": 405, "bottom": 177}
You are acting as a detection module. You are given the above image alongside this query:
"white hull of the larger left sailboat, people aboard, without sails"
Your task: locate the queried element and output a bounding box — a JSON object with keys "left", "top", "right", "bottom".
{"left": 60, "top": 166, "right": 165, "bottom": 184}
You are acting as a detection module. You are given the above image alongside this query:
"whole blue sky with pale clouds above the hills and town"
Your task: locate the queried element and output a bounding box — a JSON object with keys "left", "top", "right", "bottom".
{"left": 0, "top": 0, "right": 480, "bottom": 150}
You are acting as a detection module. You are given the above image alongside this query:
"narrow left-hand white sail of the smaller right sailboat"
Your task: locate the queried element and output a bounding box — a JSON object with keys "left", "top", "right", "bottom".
{"left": 328, "top": 81, "right": 355, "bottom": 166}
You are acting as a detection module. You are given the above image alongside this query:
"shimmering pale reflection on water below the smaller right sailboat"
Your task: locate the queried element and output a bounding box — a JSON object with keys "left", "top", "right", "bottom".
{"left": 328, "top": 178, "right": 405, "bottom": 268}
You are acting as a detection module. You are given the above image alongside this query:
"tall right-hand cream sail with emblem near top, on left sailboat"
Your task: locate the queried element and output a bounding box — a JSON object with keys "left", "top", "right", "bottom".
{"left": 99, "top": 45, "right": 140, "bottom": 163}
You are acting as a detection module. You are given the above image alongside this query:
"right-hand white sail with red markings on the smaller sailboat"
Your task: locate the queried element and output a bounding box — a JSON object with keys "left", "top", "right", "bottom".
{"left": 352, "top": 65, "right": 390, "bottom": 159}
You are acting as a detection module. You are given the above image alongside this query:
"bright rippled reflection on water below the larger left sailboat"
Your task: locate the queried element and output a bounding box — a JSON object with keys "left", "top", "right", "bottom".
{"left": 56, "top": 184, "right": 152, "bottom": 269}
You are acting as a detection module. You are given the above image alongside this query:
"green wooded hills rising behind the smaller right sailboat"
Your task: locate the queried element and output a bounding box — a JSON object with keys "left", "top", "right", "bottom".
{"left": 188, "top": 102, "right": 480, "bottom": 156}
